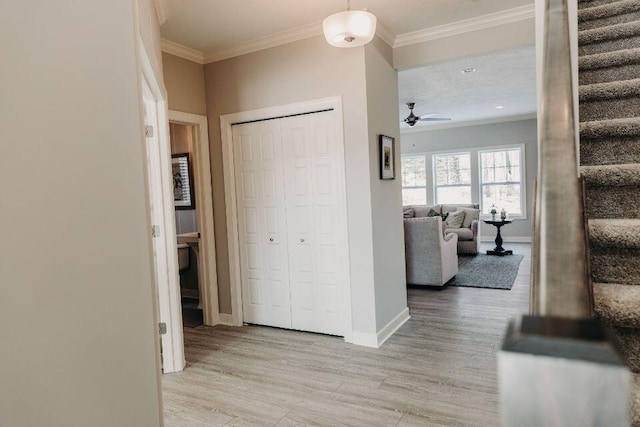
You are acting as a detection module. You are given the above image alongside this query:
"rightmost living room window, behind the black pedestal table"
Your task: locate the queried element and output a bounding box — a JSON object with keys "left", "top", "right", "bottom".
{"left": 480, "top": 147, "right": 524, "bottom": 217}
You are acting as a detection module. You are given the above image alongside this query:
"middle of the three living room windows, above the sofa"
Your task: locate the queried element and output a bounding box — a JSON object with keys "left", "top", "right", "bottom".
{"left": 433, "top": 153, "right": 471, "bottom": 204}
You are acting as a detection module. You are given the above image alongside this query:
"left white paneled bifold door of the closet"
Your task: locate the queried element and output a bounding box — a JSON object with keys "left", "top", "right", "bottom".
{"left": 233, "top": 121, "right": 291, "bottom": 328}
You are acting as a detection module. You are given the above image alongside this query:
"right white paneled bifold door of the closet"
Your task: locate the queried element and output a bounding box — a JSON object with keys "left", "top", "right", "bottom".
{"left": 282, "top": 112, "right": 344, "bottom": 335}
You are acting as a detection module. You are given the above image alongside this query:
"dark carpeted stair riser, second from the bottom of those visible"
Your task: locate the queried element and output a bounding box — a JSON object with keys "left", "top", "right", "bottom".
{"left": 591, "top": 248, "right": 640, "bottom": 285}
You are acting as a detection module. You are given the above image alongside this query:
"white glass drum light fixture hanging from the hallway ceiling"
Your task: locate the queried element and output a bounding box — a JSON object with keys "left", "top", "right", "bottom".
{"left": 322, "top": 0, "right": 376, "bottom": 47}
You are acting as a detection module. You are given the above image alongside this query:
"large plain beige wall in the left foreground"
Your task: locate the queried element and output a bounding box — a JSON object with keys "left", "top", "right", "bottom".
{"left": 0, "top": 0, "right": 161, "bottom": 427}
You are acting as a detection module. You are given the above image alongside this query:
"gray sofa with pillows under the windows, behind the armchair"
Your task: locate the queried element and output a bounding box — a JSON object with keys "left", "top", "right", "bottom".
{"left": 404, "top": 203, "right": 480, "bottom": 255}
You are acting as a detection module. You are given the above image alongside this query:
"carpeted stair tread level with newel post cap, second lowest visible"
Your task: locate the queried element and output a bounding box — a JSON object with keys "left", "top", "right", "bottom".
{"left": 593, "top": 283, "right": 640, "bottom": 328}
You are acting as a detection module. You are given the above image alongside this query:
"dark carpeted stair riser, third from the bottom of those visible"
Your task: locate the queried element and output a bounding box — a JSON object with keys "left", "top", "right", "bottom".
{"left": 587, "top": 187, "right": 640, "bottom": 219}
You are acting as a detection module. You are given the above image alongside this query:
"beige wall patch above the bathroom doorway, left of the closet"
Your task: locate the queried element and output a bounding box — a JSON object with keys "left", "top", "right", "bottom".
{"left": 162, "top": 52, "right": 207, "bottom": 116}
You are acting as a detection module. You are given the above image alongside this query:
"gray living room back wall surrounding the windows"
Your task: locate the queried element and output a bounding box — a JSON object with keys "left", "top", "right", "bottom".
{"left": 401, "top": 119, "right": 538, "bottom": 241}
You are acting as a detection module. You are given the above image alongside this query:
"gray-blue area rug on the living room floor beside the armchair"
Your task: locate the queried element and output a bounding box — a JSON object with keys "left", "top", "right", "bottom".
{"left": 447, "top": 254, "right": 524, "bottom": 290}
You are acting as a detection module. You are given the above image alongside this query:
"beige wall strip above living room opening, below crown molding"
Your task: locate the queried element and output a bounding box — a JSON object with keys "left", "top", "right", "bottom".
{"left": 393, "top": 18, "right": 535, "bottom": 70}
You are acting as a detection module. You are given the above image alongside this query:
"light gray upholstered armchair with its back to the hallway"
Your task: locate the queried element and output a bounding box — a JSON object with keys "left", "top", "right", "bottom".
{"left": 404, "top": 216, "right": 458, "bottom": 286}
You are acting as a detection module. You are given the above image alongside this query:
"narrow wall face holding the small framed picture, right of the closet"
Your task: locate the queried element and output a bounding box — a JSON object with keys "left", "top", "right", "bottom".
{"left": 365, "top": 37, "right": 407, "bottom": 331}
